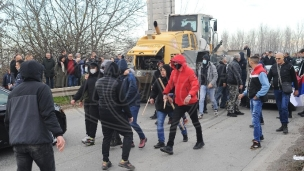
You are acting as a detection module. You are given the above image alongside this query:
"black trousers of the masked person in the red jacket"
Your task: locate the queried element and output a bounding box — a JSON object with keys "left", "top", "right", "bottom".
{"left": 167, "top": 103, "right": 203, "bottom": 147}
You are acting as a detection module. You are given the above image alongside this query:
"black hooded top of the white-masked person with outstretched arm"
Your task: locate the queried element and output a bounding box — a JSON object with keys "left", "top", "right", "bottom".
{"left": 73, "top": 63, "right": 99, "bottom": 105}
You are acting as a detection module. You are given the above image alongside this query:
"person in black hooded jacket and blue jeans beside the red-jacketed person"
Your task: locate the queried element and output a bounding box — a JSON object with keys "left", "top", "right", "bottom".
{"left": 150, "top": 65, "right": 188, "bottom": 148}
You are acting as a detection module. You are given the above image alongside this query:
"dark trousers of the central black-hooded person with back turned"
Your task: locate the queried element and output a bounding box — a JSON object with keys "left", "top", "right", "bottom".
{"left": 101, "top": 125, "right": 133, "bottom": 162}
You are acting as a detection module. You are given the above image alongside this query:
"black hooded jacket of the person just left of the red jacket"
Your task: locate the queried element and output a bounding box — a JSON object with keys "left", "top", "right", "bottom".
{"left": 150, "top": 65, "right": 174, "bottom": 113}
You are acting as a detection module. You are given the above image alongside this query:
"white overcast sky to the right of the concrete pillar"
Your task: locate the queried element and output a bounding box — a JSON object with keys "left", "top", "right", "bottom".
{"left": 139, "top": 0, "right": 304, "bottom": 34}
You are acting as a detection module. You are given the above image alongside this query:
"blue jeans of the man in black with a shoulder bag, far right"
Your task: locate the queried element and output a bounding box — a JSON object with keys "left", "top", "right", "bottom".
{"left": 274, "top": 90, "right": 290, "bottom": 124}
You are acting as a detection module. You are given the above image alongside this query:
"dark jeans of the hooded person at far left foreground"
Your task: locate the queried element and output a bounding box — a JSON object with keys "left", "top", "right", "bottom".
{"left": 13, "top": 144, "right": 55, "bottom": 171}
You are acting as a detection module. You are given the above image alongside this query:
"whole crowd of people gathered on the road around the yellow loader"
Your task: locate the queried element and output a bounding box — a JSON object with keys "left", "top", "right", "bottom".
{"left": 5, "top": 45, "right": 304, "bottom": 170}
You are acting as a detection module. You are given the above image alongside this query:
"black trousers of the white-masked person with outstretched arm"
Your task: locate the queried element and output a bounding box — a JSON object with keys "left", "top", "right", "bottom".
{"left": 84, "top": 104, "right": 99, "bottom": 138}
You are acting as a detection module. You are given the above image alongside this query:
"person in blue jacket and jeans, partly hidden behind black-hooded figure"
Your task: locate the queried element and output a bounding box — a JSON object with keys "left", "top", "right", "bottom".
{"left": 117, "top": 58, "right": 147, "bottom": 148}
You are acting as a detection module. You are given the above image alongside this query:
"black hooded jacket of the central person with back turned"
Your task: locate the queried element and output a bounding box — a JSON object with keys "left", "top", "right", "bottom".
{"left": 95, "top": 61, "right": 132, "bottom": 131}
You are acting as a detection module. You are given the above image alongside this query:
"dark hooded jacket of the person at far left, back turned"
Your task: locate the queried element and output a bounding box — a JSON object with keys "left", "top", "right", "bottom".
{"left": 5, "top": 60, "right": 63, "bottom": 145}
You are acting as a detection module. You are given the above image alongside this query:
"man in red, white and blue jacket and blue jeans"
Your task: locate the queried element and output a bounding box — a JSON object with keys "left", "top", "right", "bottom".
{"left": 239, "top": 56, "right": 270, "bottom": 149}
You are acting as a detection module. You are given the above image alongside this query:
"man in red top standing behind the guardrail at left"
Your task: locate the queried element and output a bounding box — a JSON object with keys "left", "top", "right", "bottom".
{"left": 65, "top": 53, "right": 76, "bottom": 87}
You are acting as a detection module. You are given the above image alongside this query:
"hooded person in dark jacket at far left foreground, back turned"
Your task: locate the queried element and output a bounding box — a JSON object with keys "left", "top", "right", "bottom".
{"left": 5, "top": 60, "right": 65, "bottom": 171}
